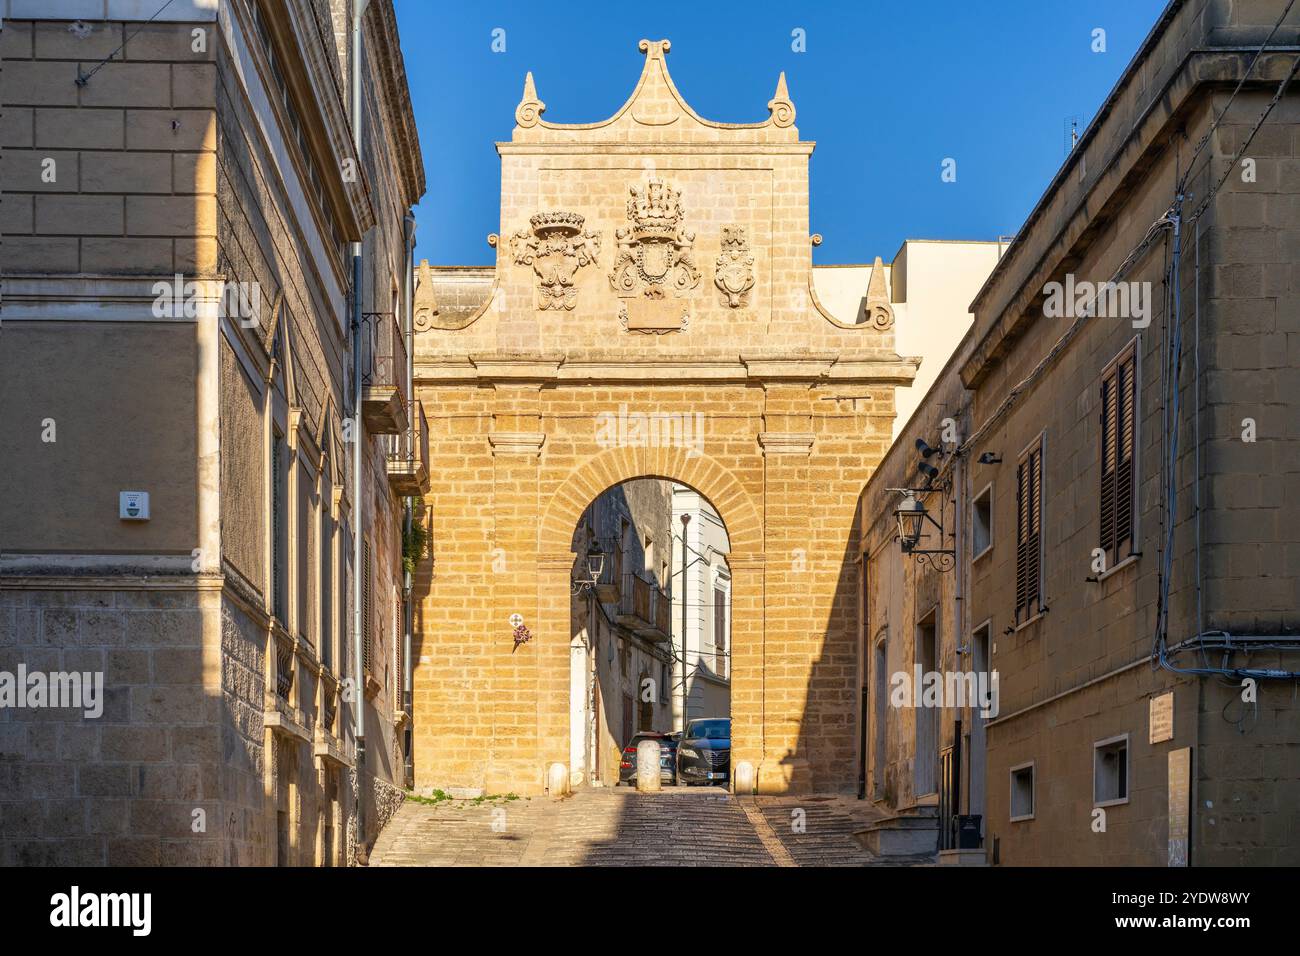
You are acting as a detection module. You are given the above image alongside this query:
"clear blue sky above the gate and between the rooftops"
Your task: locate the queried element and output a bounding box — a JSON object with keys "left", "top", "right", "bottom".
{"left": 395, "top": 0, "right": 1165, "bottom": 265}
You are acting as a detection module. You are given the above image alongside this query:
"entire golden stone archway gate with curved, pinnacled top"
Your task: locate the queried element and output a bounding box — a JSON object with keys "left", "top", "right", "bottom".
{"left": 412, "top": 40, "right": 917, "bottom": 793}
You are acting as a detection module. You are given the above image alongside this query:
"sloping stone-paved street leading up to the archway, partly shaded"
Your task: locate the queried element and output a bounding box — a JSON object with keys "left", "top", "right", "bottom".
{"left": 371, "top": 787, "right": 930, "bottom": 866}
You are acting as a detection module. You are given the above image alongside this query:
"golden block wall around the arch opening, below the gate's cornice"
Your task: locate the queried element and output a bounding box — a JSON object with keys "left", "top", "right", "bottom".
{"left": 415, "top": 377, "right": 888, "bottom": 792}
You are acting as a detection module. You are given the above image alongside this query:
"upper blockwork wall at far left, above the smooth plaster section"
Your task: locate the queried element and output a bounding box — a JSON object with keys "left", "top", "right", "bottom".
{"left": 0, "top": 20, "right": 218, "bottom": 276}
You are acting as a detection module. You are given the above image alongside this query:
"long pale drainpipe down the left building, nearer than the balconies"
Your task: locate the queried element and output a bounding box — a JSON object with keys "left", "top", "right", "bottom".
{"left": 350, "top": 0, "right": 371, "bottom": 853}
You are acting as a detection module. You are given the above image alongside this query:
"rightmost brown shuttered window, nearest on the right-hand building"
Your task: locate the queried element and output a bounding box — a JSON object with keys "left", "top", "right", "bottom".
{"left": 1100, "top": 339, "right": 1138, "bottom": 568}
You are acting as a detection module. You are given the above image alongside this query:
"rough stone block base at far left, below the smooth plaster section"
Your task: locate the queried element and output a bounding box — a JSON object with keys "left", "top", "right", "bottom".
{"left": 0, "top": 581, "right": 215, "bottom": 866}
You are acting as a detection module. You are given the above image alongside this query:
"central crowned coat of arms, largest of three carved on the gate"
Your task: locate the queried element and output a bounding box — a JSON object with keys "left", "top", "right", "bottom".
{"left": 610, "top": 179, "right": 699, "bottom": 299}
